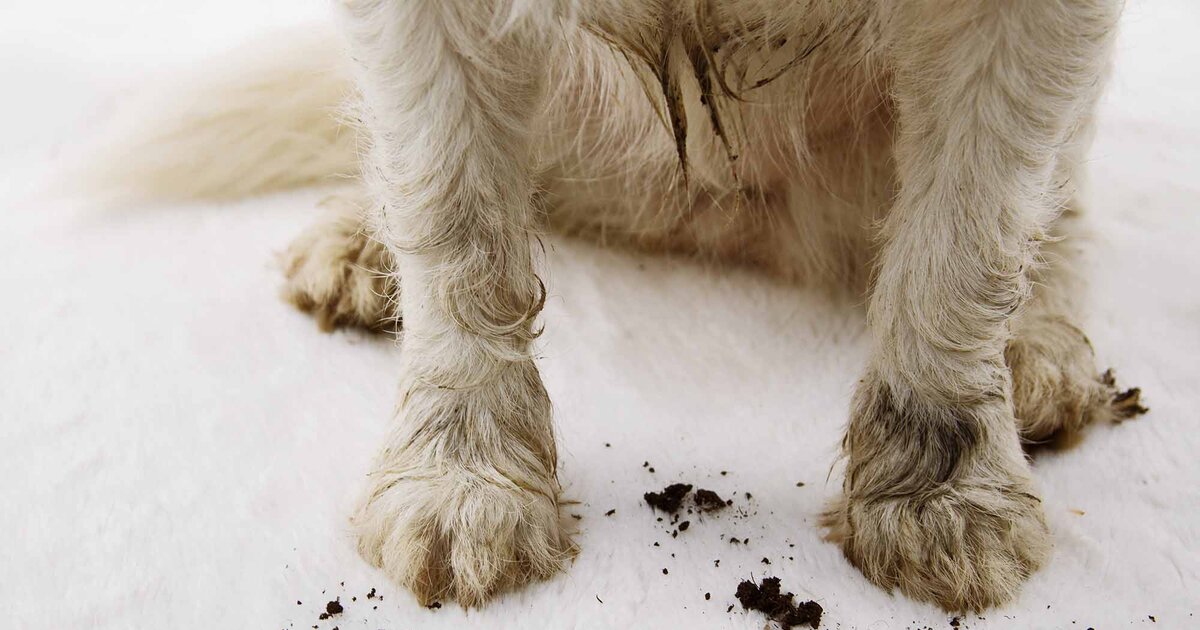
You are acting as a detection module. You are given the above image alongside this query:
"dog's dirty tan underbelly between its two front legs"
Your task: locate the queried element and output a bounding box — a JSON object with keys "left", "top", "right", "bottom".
{"left": 539, "top": 22, "right": 894, "bottom": 288}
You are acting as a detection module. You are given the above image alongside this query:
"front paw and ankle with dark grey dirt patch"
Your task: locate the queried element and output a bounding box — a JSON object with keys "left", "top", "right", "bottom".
{"left": 823, "top": 376, "right": 1050, "bottom": 612}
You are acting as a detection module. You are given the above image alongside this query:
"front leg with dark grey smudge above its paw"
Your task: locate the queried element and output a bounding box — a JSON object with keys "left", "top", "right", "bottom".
{"left": 827, "top": 0, "right": 1117, "bottom": 611}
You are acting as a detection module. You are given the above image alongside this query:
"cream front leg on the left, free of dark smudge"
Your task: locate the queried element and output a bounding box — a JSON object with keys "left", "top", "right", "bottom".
{"left": 344, "top": 0, "right": 572, "bottom": 606}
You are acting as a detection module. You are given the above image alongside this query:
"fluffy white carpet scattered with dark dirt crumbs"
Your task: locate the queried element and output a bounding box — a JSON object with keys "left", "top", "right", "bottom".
{"left": 0, "top": 0, "right": 1200, "bottom": 630}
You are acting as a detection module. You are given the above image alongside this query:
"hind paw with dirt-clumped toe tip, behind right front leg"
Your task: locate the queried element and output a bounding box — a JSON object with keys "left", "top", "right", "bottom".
{"left": 1004, "top": 316, "right": 1148, "bottom": 445}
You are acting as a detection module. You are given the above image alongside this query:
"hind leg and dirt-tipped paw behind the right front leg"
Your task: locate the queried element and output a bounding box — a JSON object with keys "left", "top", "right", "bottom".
{"left": 1004, "top": 200, "right": 1147, "bottom": 445}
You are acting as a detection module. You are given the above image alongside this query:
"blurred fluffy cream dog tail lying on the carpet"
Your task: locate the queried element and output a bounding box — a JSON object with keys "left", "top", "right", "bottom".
{"left": 76, "top": 26, "right": 359, "bottom": 203}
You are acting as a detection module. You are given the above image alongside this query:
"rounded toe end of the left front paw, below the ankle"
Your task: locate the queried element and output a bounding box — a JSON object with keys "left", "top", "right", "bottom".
{"left": 354, "top": 470, "right": 574, "bottom": 607}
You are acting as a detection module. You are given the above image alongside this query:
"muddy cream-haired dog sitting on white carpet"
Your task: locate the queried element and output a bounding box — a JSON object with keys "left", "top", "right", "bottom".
{"left": 88, "top": 0, "right": 1146, "bottom": 611}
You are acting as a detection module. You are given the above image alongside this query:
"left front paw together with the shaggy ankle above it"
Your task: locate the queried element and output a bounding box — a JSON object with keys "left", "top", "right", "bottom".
{"left": 353, "top": 361, "right": 575, "bottom": 606}
